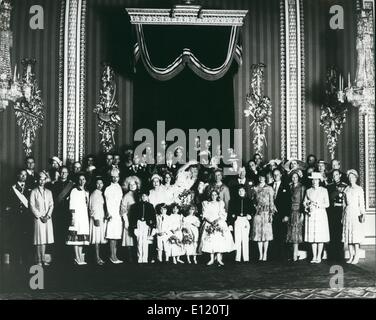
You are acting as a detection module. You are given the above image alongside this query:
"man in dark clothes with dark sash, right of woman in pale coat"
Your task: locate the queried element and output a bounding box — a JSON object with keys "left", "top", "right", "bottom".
{"left": 52, "top": 166, "right": 74, "bottom": 261}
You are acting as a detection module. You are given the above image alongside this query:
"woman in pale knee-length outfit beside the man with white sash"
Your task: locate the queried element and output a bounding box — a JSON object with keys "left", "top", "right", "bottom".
{"left": 30, "top": 172, "right": 54, "bottom": 266}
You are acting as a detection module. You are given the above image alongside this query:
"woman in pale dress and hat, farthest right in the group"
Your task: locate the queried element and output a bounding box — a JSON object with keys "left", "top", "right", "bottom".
{"left": 342, "top": 169, "right": 365, "bottom": 264}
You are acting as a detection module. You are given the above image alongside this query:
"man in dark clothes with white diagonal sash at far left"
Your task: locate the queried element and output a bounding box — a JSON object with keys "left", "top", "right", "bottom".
{"left": 6, "top": 170, "right": 33, "bottom": 263}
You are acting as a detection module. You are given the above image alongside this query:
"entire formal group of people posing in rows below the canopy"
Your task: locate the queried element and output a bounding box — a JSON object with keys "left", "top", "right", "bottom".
{"left": 5, "top": 147, "right": 365, "bottom": 266}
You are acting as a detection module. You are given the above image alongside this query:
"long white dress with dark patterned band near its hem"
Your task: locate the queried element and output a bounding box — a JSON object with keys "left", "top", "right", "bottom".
{"left": 66, "top": 188, "right": 90, "bottom": 245}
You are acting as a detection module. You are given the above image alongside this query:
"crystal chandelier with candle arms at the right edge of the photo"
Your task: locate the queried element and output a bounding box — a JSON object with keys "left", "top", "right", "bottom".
{"left": 338, "top": 2, "right": 375, "bottom": 115}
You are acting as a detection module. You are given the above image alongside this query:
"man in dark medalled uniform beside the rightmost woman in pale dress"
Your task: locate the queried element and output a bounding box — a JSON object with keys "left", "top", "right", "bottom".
{"left": 327, "top": 169, "right": 347, "bottom": 260}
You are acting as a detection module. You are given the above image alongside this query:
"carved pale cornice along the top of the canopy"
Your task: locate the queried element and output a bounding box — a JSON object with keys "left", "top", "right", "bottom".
{"left": 126, "top": 5, "right": 248, "bottom": 26}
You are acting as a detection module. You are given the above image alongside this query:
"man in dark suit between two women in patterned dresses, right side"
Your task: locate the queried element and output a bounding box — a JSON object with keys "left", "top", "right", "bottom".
{"left": 270, "top": 168, "right": 291, "bottom": 260}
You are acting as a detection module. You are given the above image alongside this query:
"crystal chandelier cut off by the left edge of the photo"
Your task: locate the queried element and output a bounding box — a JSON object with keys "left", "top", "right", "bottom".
{"left": 0, "top": 0, "right": 22, "bottom": 112}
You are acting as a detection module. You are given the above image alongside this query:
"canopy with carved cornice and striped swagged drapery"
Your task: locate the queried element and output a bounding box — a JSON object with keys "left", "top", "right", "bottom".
{"left": 126, "top": 5, "right": 248, "bottom": 81}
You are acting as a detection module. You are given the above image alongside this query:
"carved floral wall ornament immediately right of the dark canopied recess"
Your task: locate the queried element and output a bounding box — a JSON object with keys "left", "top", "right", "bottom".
{"left": 244, "top": 63, "right": 272, "bottom": 154}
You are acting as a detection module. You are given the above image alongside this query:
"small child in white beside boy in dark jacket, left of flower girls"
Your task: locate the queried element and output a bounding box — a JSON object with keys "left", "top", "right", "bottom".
{"left": 156, "top": 203, "right": 171, "bottom": 262}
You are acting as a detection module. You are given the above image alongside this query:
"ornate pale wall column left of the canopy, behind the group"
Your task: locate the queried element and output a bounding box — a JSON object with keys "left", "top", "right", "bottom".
{"left": 58, "top": 0, "right": 86, "bottom": 163}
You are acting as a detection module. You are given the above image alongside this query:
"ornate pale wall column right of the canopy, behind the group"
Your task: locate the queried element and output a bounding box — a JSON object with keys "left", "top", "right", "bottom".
{"left": 280, "top": 0, "right": 305, "bottom": 160}
